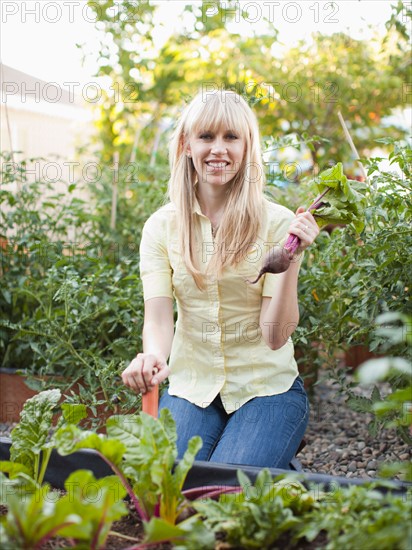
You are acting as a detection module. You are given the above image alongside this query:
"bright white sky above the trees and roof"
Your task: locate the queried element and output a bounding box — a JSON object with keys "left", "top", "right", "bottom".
{"left": 0, "top": 0, "right": 396, "bottom": 85}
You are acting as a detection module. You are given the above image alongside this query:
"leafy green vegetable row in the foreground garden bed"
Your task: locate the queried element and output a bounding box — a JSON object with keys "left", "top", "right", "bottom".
{"left": 0, "top": 390, "right": 412, "bottom": 550}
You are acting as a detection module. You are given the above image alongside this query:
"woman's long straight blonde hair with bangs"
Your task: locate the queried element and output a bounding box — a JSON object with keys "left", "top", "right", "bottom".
{"left": 168, "top": 90, "right": 265, "bottom": 289}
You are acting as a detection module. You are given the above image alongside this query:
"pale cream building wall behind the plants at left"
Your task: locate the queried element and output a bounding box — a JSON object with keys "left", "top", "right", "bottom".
{"left": 0, "top": 66, "right": 94, "bottom": 242}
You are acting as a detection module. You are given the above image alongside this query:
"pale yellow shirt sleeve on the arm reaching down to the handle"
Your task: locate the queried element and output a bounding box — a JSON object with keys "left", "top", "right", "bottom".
{"left": 140, "top": 213, "right": 173, "bottom": 301}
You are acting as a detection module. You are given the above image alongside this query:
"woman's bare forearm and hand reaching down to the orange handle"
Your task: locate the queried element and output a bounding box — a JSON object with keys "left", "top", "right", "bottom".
{"left": 122, "top": 297, "right": 174, "bottom": 394}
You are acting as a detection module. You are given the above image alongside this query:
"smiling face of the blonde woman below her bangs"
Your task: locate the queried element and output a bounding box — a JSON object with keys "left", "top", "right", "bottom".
{"left": 186, "top": 127, "right": 245, "bottom": 189}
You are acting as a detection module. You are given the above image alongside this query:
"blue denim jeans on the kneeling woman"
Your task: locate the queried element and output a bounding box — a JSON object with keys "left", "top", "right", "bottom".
{"left": 159, "top": 376, "right": 309, "bottom": 469}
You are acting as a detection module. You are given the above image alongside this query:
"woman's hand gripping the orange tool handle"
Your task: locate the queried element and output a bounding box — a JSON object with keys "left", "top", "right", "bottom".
{"left": 122, "top": 353, "right": 170, "bottom": 394}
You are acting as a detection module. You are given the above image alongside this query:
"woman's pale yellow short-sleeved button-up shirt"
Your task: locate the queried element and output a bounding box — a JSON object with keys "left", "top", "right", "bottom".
{"left": 140, "top": 201, "right": 298, "bottom": 413}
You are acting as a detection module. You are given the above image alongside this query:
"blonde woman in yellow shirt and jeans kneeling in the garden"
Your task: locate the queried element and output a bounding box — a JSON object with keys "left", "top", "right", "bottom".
{"left": 122, "top": 91, "right": 319, "bottom": 468}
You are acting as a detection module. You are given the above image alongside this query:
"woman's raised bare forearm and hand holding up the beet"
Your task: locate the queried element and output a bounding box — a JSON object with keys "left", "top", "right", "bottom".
{"left": 260, "top": 207, "right": 319, "bottom": 350}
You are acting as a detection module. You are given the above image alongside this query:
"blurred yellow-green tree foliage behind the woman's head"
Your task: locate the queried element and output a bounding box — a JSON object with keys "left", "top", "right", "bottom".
{"left": 83, "top": 0, "right": 407, "bottom": 171}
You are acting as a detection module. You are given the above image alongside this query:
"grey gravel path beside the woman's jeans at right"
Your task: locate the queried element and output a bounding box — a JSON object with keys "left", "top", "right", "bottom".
{"left": 0, "top": 381, "right": 412, "bottom": 484}
